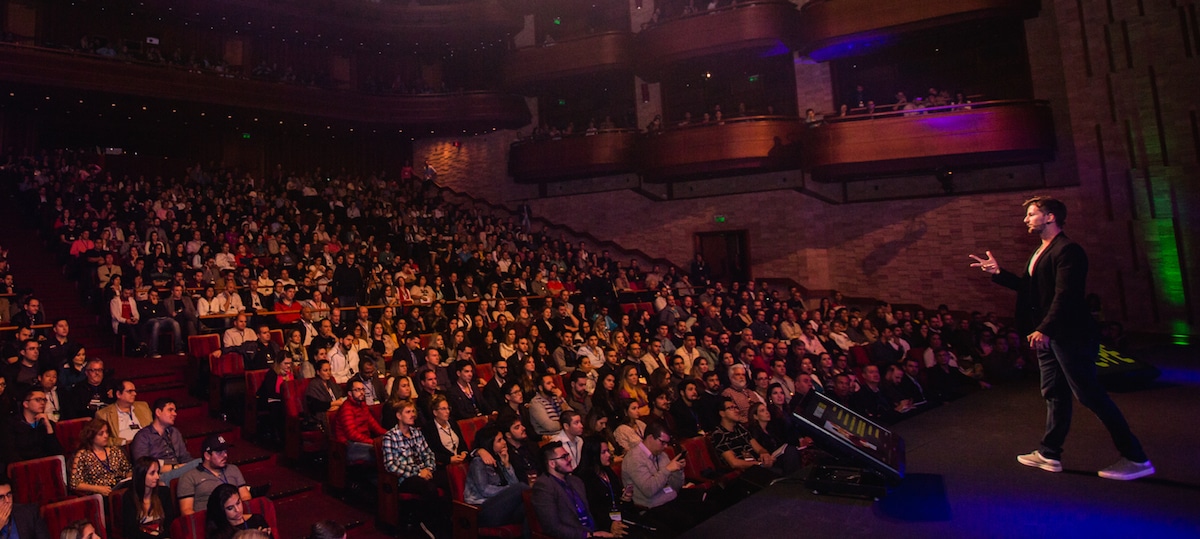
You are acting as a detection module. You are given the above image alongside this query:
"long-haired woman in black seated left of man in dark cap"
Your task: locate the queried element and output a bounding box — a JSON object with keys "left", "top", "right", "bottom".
{"left": 120, "top": 456, "right": 179, "bottom": 539}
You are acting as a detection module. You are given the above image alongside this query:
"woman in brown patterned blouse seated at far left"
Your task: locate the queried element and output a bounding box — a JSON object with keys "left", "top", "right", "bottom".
{"left": 67, "top": 419, "right": 133, "bottom": 496}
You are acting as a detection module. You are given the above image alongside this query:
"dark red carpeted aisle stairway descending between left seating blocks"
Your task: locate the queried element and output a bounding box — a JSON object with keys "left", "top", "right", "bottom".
{"left": 2, "top": 200, "right": 398, "bottom": 539}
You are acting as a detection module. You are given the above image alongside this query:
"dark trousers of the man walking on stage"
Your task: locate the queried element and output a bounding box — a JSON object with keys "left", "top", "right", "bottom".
{"left": 1038, "top": 339, "right": 1148, "bottom": 462}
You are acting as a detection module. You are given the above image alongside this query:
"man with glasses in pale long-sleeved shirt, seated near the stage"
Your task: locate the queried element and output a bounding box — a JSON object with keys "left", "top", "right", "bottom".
{"left": 620, "top": 423, "right": 703, "bottom": 532}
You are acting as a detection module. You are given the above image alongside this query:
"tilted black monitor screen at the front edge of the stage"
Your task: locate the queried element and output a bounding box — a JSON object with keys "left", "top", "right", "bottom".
{"left": 793, "top": 391, "right": 904, "bottom": 483}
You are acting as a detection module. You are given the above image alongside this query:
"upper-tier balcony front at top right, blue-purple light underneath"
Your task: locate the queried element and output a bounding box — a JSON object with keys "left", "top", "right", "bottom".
{"left": 800, "top": 0, "right": 1040, "bottom": 61}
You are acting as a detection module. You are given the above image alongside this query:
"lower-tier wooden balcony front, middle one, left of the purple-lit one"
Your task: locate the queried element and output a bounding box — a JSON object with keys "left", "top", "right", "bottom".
{"left": 640, "top": 116, "right": 803, "bottom": 181}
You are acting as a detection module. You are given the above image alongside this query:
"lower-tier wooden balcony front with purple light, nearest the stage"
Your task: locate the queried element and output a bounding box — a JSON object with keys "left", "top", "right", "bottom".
{"left": 802, "top": 101, "right": 1055, "bottom": 181}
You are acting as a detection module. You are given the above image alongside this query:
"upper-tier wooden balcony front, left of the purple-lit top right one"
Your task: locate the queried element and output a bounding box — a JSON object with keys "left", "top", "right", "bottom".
{"left": 637, "top": 1, "right": 800, "bottom": 76}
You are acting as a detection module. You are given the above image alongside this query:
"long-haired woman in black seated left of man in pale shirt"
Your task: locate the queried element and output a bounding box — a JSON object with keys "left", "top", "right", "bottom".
{"left": 574, "top": 435, "right": 635, "bottom": 537}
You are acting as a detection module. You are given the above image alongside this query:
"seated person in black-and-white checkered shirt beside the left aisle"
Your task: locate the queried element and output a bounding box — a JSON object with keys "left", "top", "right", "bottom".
{"left": 383, "top": 401, "right": 450, "bottom": 537}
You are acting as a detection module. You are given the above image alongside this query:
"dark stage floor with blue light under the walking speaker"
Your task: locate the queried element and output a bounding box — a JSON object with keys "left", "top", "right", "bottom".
{"left": 684, "top": 346, "right": 1200, "bottom": 539}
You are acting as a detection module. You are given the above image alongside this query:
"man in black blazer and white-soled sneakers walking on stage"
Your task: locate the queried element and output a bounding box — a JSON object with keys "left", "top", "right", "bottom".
{"left": 971, "top": 197, "right": 1154, "bottom": 480}
